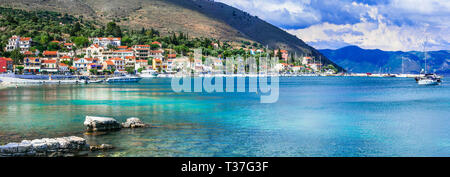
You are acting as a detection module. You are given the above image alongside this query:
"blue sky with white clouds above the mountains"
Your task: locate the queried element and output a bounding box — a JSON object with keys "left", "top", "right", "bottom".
{"left": 216, "top": 0, "right": 450, "bottom": 51}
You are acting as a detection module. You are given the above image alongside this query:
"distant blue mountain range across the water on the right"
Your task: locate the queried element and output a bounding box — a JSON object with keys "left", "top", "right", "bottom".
{"left": 320, "top": 46, "right": 450, "bottom": 74}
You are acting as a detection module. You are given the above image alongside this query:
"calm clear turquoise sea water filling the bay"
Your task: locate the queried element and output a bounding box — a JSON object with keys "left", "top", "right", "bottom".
{"left": 0, "top": 77, "right": 450, "bottom": 157}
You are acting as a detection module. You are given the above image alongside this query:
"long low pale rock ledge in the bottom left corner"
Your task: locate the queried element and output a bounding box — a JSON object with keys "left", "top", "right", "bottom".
{"left": 0, "top": 136, "right": 89, "bottom": 157}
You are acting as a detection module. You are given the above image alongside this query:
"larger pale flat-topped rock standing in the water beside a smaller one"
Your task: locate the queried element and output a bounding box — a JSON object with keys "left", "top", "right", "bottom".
{"left": 84, "top": 116, "right": 122, "bottom": 132}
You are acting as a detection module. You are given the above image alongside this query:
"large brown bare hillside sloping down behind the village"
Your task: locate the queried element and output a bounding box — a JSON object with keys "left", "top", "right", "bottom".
{"left": 0, "top": 0, "right": 342, "bottom": 69}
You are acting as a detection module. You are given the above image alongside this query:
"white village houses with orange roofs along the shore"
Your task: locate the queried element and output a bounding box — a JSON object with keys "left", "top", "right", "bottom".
{"left": 0, "top": 35, "right": 335, "bottom": 76}
